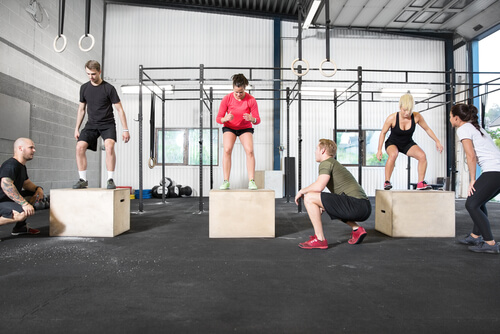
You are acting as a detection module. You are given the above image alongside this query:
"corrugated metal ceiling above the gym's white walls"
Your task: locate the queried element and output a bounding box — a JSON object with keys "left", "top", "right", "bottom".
{"left": 106, "top": 0, "right": 500, "bottom": 40}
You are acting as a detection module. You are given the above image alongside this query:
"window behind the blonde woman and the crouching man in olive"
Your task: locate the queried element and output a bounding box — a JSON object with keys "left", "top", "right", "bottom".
{"left": 336, "top": 130, "right": 388, "bottom": 167}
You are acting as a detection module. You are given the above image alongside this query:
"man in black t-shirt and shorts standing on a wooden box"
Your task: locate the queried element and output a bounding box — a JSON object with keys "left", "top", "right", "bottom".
{"left": 73, "top": 60, "right": 130, "bottom": 189}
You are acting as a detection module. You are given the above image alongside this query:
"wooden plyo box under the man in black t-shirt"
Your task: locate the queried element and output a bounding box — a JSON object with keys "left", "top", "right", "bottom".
{"left": 50, "top": 188, "right": 130, "bottom": 237}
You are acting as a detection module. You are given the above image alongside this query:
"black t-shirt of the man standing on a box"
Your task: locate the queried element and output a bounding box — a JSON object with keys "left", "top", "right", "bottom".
{"left": 80, "top": 80, "right": 120, "bottom": 129}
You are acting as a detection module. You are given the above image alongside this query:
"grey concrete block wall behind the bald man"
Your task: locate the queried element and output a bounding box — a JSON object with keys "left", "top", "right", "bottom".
{"left": 0, "top": 0, "right": 104, "bottom": 192}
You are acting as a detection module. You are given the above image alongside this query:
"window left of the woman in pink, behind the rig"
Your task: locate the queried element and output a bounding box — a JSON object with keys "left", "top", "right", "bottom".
{"left": 156, "top": 128, "right": 219, "bottom": 166}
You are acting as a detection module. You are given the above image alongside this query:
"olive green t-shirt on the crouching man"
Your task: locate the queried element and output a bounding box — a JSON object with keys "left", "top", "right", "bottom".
{"left": 319, "top": 158, "right": 368, "bottom": 199}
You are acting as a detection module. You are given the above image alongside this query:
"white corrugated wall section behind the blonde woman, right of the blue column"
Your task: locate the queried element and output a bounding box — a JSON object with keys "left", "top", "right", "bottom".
{"left": 281, "top": 23, "right": 447, "bottom": 196}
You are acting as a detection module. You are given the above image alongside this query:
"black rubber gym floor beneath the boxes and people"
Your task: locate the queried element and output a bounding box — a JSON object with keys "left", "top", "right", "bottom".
{"left": 0, "top": 198, "right": 500, "bottom": 334}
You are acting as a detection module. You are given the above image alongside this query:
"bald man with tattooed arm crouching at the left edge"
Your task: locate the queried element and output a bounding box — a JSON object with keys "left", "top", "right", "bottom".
{"left": 0, "top": 138, "right": 43, "bottom": 235}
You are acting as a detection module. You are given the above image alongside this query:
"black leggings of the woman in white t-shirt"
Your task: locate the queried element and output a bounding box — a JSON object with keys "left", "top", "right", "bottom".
{"left": 465, "top": 172, "right": 500, "bottom": 241}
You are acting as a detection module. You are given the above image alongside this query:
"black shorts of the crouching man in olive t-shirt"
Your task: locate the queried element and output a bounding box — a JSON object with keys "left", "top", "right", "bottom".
{"left": 321, "top": 192, "right": 372, "bottom": 223}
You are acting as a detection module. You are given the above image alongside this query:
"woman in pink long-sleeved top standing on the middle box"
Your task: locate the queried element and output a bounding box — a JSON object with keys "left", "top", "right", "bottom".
{"left": 217, "top": 73, "right": 260, "bottom": 190}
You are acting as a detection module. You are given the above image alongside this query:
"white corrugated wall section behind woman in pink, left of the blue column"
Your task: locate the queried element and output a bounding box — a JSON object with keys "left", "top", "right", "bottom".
{"left": 102, "top": 5, "right": 274, "bottom": 196}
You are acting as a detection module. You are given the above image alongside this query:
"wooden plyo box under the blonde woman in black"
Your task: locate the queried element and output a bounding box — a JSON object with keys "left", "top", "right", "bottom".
{"left": 375, "top": 190, "right": 455, "bottom": 237}
